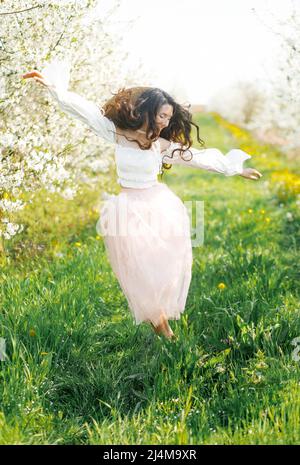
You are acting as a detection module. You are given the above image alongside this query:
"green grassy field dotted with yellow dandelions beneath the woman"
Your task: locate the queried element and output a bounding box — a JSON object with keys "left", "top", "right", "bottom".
{"left": 0, "top": 114, "right": 300, "bottom": 444}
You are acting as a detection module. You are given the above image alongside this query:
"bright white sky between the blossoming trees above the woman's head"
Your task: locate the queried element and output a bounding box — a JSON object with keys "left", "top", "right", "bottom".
{"left": 87, "top": 0, "right": 300, "bottom": 104}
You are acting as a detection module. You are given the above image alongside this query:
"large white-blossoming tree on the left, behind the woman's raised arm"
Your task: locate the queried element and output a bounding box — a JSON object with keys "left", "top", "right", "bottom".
{"left": 0, "top": 0, "right": 146, "bottom": 245}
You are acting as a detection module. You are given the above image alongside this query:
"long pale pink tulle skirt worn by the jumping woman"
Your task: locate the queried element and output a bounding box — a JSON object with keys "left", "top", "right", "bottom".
{"left": 96, "top": 183, "right": 193, "bottom": 325}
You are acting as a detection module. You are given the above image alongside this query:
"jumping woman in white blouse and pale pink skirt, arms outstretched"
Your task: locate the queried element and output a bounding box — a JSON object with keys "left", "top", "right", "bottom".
{"left": 22, "top": 62, "right": 262, "bottom": 339}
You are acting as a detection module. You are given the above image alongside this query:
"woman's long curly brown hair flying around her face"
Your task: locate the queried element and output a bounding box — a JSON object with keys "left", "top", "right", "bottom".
{"left": 102, "top": 87, "right": 205, "bottom": 175}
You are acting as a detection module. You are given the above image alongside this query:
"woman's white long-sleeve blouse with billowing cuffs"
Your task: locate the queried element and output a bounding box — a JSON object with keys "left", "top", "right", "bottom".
{"left": 42, "top": 61, "right": 251, "bottom": 188}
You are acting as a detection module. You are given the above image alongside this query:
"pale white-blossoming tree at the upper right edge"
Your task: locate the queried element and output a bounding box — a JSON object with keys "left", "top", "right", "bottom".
{"left": 208, "top": 2, "right": 300, "bottom": 152}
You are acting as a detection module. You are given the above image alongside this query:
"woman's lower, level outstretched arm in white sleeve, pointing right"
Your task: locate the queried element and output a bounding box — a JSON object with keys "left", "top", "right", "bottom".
{"left": 161, "top": 142, "right": 262, "bottom": 179}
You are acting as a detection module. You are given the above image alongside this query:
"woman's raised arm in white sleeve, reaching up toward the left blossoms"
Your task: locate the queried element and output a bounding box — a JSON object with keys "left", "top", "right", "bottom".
{"left": 22, "top": 62, "right": 116, "bottom": 143}
